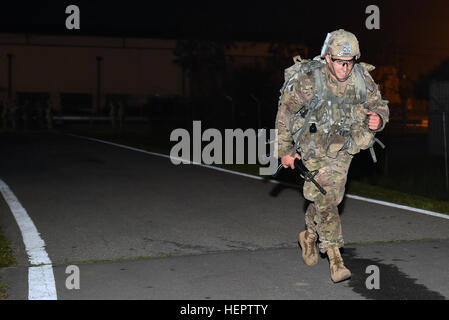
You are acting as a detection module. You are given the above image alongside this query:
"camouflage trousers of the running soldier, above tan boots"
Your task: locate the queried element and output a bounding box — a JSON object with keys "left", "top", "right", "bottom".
{"left": 303, "top": 153, "right": 353, "bottom": 253}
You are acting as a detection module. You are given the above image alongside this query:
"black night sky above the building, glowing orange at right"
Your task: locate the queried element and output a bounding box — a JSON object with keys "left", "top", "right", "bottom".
{"left": 0, "top": 0, "right": 449, "bottom": 78}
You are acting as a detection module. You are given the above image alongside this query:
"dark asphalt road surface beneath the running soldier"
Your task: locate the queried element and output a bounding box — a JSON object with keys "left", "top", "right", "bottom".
{"left": 0, "top": 133, "right": 449, "bottom": 301}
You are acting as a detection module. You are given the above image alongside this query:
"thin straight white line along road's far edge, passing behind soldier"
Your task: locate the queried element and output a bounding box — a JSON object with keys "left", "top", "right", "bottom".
{"left": 66, "top": 134, "right": 449, "bottom": 220}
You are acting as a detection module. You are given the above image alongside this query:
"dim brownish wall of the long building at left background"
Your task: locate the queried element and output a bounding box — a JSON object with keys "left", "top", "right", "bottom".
{"left": 0, "top": 35, "right": 182, "bottom": 103}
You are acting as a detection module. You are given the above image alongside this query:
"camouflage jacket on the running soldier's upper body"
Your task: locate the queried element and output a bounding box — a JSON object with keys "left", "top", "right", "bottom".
{"left": 276, "top": 63, "right": 389, "bottom": 159}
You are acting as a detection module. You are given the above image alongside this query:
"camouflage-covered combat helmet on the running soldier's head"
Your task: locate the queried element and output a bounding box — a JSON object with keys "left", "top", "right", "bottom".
{"left": 321, "top": 29, "right": 360, "bottom": 59}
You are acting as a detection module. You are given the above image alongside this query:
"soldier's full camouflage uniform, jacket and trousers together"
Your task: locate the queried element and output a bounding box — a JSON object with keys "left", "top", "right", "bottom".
{"left": 276, "top": 31, "right": 389, "bottom": 253}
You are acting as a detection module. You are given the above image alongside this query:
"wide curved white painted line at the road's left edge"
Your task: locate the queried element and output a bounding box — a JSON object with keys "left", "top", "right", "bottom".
{"left": 0, "top": 179, "right": 57, "bottom": 300}
